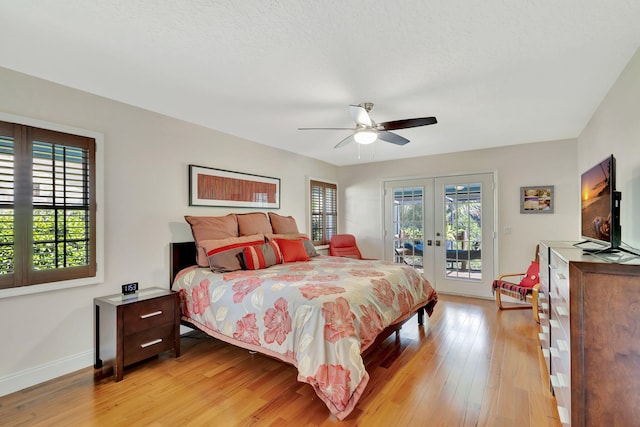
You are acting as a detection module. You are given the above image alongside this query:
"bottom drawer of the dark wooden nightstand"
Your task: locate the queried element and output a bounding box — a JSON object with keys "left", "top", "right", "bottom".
{"left": 124, "top": 323, "right": 175, "bottom": 366}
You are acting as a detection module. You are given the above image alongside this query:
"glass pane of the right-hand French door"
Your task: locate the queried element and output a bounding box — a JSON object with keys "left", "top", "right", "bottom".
{"left": 443, "top": 183, "right": 482, "bottom": 281}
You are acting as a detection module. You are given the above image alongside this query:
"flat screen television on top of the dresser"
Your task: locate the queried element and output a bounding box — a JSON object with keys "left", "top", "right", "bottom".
{"left": 580, "top": 155, "right": 621, "bottom": 252}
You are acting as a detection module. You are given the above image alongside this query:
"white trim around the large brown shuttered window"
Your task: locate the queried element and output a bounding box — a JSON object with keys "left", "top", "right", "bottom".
{"left": 0, "top": 111, "right": 104, "bottom": 298}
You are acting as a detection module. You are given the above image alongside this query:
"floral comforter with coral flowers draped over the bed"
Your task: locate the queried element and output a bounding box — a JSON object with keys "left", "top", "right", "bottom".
{"left": 173, "top": 256, "right": 437, "bottom": 419}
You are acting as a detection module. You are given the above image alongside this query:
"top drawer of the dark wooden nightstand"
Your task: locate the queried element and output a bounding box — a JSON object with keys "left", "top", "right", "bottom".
{"left": 123, "top": 296, "right": 176, "bottom": 335}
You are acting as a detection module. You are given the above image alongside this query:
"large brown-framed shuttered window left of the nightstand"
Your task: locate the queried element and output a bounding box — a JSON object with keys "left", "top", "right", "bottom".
{"left": 0, "top": 121, "right": 97, "bottom": 289}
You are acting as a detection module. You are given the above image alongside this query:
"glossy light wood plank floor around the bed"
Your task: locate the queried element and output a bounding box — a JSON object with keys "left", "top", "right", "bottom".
{"left": 0, "top": 295, "right": 560, "bottom": 427}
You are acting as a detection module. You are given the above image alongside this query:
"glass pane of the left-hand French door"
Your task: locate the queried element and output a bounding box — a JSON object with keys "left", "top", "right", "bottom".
{"left": 393, "top": 187, "right": 424, "bottom": 269}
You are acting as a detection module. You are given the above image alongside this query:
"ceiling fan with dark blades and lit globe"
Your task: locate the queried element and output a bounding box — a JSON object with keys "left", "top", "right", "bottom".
{"left": 298, "top": 102, "right": 438, "bottom": 148}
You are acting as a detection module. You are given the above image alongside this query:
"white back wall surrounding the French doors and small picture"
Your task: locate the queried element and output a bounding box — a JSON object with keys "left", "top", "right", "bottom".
{"left": 338, "top": 139, "right": 580, "bottom": 280}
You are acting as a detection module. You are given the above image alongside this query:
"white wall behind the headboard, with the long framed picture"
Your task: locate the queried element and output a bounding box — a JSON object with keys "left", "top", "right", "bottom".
{"left": 0, "top": 68, "right": 338, "bottom": 395}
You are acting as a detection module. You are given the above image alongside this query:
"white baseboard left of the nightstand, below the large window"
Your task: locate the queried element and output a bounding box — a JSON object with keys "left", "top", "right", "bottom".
{"left": 0, "top": 349, "right": 95, "bottom": 396}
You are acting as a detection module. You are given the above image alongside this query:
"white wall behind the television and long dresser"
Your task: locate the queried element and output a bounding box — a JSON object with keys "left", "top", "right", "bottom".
{"left": 578, "top": 49, "right": 640, "bottom": 249}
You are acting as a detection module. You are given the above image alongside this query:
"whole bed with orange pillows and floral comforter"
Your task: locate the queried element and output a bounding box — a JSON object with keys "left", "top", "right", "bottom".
{"left": 170, "top": 212, "right": 438, "bottom": 419}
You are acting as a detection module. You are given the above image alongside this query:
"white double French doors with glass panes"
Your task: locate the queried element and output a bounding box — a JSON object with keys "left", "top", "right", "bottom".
{"left": 384, "top": 173, "right": 495, "bottom": 297}
